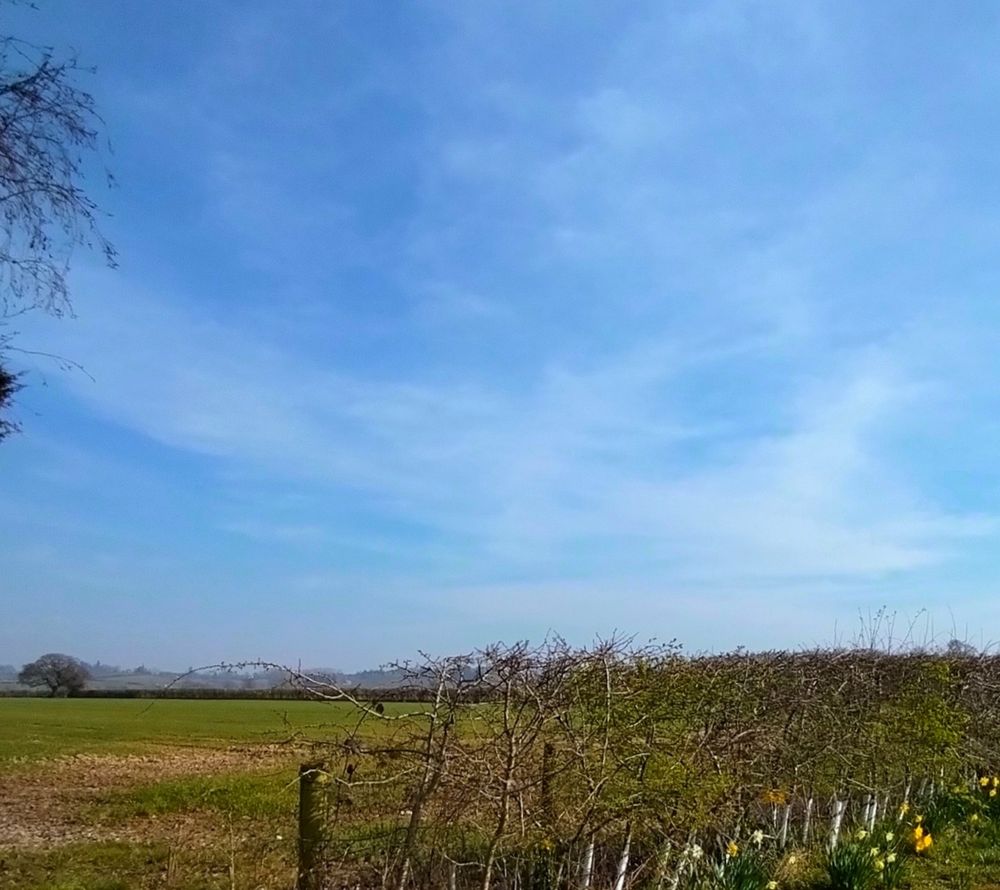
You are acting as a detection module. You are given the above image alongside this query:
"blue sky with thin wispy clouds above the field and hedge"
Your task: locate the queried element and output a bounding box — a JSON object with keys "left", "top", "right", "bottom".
{"left": 0, "top": 0, "right": 1000, "bottom": 668}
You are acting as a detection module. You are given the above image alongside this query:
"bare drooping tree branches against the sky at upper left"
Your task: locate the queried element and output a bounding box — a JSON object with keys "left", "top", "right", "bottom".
{"left": 0, "top": 15, "right": 115, "bottom": 440}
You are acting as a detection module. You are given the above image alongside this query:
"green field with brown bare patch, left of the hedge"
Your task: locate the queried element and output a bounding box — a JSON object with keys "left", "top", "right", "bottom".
{"left": 0, "top": 698, "right": 404, "bottom": 890}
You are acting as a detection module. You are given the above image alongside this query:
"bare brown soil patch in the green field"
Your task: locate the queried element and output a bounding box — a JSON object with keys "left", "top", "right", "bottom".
{"left": 0, "top": 745, "right": 296, "bottom": 851}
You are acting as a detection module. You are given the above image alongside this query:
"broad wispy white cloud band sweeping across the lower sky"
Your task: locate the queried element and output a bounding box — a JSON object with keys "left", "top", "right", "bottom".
{"left": 25, "top": 260, "right": 993, "bottom": 581}
